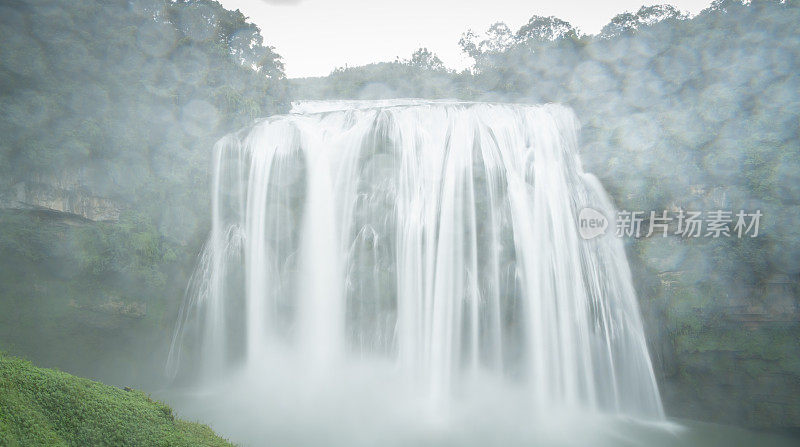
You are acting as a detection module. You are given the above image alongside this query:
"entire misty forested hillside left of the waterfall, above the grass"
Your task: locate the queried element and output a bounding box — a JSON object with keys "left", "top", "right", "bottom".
{"left": 0, "top": 0, "right": 288, "bottom": 386}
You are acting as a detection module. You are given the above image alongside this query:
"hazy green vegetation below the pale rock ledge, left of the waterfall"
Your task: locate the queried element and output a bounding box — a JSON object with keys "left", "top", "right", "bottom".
{"left": 0, "top": 211, "right": 188, "bottom": 384}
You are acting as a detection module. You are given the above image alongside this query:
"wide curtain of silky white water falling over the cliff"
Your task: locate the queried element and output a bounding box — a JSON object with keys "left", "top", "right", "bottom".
{"left": 168, "top": 100, "right": 663, "bottom": 419}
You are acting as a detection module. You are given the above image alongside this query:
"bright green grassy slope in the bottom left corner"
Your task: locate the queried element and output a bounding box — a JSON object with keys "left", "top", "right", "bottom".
{"left": 0, "top": 353, "right": 231, "bottom": 446}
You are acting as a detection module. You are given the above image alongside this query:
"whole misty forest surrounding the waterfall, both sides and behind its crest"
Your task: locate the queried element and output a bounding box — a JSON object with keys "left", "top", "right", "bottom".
{"left": 0, "top": 0, "right": 800, "bottom": 442}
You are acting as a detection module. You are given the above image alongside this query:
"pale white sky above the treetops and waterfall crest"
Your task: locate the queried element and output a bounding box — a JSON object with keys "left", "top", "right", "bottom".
{"left": 219, "top": 0, "right": 711, "bottom": 78}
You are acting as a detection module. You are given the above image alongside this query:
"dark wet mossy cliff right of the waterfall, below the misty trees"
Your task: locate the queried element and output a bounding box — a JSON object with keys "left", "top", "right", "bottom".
{"left": 628, "top": 240, "right": 800, "bottom": 429}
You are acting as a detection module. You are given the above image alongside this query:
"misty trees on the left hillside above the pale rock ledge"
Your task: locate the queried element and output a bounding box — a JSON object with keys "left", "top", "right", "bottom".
{"left": 0, "top": 0, "right": 285, "bottom": 177}
